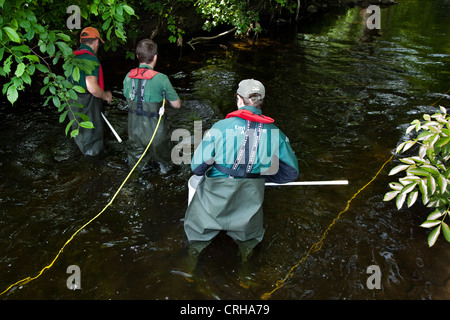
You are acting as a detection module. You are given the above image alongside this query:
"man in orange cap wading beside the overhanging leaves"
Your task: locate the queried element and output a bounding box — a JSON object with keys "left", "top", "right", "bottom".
{"left": 68, "top": 27, "right": 112, "bottom": 156}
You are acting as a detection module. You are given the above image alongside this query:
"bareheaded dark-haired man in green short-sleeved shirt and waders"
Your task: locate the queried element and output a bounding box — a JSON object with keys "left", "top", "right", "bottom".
{"left": 123, "top": 39, "right": 181, "bottom": 173}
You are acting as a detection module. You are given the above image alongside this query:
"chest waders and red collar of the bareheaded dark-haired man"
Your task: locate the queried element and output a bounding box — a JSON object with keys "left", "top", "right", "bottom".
{"left": 127, "top": 68, "right": 173, "bottom": 169}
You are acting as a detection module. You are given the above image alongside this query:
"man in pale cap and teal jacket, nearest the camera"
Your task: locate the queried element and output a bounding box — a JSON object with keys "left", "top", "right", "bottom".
{"left": 184, "top": 79, "right": 299, "bottom": 268}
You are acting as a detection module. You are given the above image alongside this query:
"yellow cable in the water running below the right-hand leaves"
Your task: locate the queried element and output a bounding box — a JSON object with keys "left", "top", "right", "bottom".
{"left": 261, "top": 154, "right": 394, "bottom": 300}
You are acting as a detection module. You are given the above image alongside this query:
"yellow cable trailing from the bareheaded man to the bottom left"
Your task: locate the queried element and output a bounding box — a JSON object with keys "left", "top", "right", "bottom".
{"left": 0, "top": 99, "right": 166, "bottom": 296}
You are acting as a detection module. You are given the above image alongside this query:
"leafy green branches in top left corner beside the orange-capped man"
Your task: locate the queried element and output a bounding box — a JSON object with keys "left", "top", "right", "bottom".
{"left": 0, "top": 0, "right": 135, "bottom": 136}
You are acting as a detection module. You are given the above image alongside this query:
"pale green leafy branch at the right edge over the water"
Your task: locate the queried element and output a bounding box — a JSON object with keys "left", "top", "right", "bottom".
{"left": 384, "top": 107, "right": 450, "bottom": 247}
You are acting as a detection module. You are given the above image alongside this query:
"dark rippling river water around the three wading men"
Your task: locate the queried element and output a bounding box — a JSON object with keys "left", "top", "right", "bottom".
{"left": 0, "top": 0, "right": 450, "bottom": 300}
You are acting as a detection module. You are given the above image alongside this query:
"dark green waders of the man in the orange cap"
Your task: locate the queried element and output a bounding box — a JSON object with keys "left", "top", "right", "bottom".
{"left": 68, "top": 93, "right": 104, "bottom": 156}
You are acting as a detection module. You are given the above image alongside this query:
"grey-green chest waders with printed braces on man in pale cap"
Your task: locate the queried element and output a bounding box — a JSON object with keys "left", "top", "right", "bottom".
{"left": 184, "top": 120, "right": 265, "bottom": 243}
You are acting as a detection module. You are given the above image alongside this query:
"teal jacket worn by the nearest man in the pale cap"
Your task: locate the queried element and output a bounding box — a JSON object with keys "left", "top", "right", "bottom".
{"left": 191, "top": 106, "right": 299, "bottom": 183}
